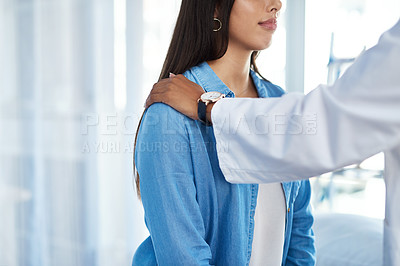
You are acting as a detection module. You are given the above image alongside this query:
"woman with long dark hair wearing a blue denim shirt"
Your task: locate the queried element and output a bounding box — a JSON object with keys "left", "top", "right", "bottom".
{"left": 133, "top": 0, "right": 315, "bottom": 265}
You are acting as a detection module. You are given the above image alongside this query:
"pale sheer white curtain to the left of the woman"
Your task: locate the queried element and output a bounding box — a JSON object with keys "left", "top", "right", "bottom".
{"left": 0, "top": 0, "right": 147, "bottom": 266}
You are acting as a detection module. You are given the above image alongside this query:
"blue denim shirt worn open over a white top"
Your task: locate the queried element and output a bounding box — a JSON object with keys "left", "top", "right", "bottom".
{"left": 133, "top": 62, "right": 315, "bottom": 266}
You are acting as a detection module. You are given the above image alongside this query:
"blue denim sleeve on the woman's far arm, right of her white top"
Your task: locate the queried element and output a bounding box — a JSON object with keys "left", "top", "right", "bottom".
{"left": 285, "top": 180, "right": 315, "bottom": 265}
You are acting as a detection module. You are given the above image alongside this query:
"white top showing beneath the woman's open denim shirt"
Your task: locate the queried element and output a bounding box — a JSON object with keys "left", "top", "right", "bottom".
{"left": 250, "top": 183, "right": 286, "bottom": 266}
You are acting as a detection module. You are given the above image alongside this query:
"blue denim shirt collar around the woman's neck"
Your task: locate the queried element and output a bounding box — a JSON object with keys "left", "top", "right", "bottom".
{"left": 191, "top": 62, "right": 268, "bottom": 98}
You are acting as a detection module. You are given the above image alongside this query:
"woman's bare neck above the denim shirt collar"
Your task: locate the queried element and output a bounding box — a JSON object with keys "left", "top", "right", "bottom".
{"left": 208, "top": 47, "right": 256, "bottom": 97}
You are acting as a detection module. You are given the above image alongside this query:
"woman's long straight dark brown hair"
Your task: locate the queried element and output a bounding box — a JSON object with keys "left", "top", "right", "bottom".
{"left": 133, "top": 0, "right": 268, "bottom": 199}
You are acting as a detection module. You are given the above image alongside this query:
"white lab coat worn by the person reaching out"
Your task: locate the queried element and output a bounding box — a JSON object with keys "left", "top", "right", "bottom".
{"left": 211, "top": 21, "right": 400, "bottom": 265}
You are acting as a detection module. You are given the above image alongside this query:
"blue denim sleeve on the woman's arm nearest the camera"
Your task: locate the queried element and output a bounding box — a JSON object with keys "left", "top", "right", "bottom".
{"left": 135, "top": 103, "right": 212, "bottom": 265}
